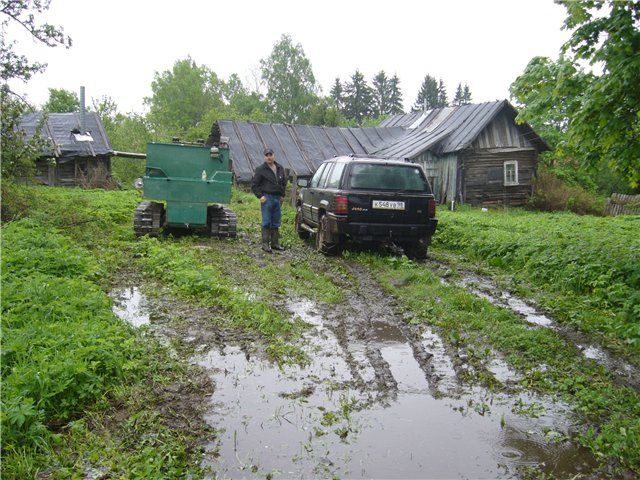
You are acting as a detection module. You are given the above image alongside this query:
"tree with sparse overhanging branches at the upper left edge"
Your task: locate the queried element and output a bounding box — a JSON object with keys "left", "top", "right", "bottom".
{"left": 0, "top": 0, "right": 71, "bottom": 182}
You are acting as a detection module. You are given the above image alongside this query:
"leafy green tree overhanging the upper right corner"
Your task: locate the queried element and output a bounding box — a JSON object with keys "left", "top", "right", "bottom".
{"left": 516, "top": 0, "right": 640, "bottom": 188}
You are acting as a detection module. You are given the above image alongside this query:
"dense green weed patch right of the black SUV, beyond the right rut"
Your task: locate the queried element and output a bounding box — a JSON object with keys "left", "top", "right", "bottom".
{"left": 434, "top": 209, "right": 640, "bottom": 354}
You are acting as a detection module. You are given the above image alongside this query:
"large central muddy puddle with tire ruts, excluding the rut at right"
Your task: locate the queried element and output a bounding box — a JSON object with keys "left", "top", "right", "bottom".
{"left": 110, "top": 255, "right": 600, "bottom": 478}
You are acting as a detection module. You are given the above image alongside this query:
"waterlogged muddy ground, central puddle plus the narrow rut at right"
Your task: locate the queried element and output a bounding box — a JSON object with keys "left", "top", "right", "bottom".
{"left": 112, "top": 235, "right": 640, "bottom": 478}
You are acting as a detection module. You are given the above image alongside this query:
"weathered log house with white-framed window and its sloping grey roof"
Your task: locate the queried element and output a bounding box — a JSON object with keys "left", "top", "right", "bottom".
{"left": 376, "top": 100, "right": 549, "bottom": 205}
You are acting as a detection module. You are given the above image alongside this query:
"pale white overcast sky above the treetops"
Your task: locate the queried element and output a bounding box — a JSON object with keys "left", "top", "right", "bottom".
{"left": 5, "top": 0, "right": 568, "bottom": 112}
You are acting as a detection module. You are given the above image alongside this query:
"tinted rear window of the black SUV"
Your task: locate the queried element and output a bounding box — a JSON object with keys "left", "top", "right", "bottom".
{"left": 349, "top": 163, "right": 430, "bottom": 192}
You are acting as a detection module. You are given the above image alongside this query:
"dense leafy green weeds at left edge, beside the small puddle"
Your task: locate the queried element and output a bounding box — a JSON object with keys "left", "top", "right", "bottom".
{"left": 1, "top": 219, "right": 142, "bottom": 451}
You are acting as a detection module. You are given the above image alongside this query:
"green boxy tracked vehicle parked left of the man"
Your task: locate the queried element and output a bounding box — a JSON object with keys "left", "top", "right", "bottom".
{"left": 133, "top": 137, "right": 237, "bottom": 238}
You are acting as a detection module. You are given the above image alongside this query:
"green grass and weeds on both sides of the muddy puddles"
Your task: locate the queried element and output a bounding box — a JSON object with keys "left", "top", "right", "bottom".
{"left": 1, "top": 188, "right": 640, "bottom": 478}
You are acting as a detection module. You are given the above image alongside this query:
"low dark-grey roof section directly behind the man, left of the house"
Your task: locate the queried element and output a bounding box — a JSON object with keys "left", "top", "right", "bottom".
{"left": 213, "top": 120, "right": 406, "bottom": 182}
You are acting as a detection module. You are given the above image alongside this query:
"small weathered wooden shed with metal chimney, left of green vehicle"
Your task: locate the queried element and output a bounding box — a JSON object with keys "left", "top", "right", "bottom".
{"left": 20, "top": 112, "right": 113, "bottom": 187}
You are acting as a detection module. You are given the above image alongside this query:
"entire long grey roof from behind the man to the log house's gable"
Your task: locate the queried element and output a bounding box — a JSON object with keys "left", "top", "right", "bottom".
{"left": 210, "top": 100, "right": 549, "bottom": 182}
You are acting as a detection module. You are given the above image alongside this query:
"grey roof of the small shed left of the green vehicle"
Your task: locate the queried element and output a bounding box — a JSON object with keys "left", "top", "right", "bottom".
{"left": 20, "top": 112, "right": 113, "bottom": 158}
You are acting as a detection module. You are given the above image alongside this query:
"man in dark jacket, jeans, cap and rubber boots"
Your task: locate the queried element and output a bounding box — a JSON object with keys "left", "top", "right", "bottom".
{"left": 251, "top": 147, "right": 287, "bottom": 252}
